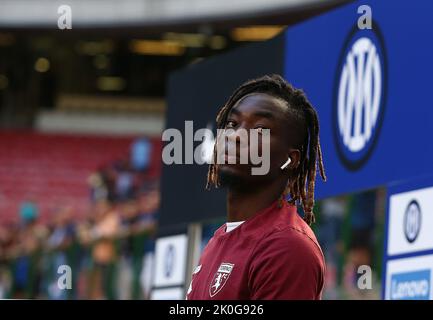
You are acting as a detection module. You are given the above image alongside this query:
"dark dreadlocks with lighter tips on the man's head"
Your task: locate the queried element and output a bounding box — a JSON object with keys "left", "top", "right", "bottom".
{"left": 206, "top": 74, "right": 326, "bottom": 225}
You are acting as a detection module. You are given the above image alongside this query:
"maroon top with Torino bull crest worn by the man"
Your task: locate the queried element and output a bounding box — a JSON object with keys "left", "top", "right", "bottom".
{"left": 186, "top": 202, "right": 325, "bottom": 300}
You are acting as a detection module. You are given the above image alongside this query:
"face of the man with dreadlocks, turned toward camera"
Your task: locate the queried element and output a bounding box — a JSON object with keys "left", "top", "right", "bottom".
{"left": 217, "top": 93, "right": 296, "bottom": 186}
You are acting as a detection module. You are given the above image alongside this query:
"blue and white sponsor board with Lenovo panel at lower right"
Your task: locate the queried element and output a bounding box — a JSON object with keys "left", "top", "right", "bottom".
{"left": 382, "top": 176, "right": 433, "bottom": 300}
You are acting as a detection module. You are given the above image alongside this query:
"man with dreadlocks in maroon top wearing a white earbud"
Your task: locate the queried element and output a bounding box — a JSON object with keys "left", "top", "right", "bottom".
{"left": 187, "top": 75, "right": 326, "bottom": 300}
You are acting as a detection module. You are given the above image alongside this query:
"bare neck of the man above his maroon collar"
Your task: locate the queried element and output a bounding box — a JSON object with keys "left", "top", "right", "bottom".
{"left": 227, "top": 180, "right": 284, "bottom": 222}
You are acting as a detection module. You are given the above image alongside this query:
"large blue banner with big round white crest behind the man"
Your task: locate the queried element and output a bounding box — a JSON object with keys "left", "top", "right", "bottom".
{"left": 285, "top": 0, "right": 433, "bottom": 198}
